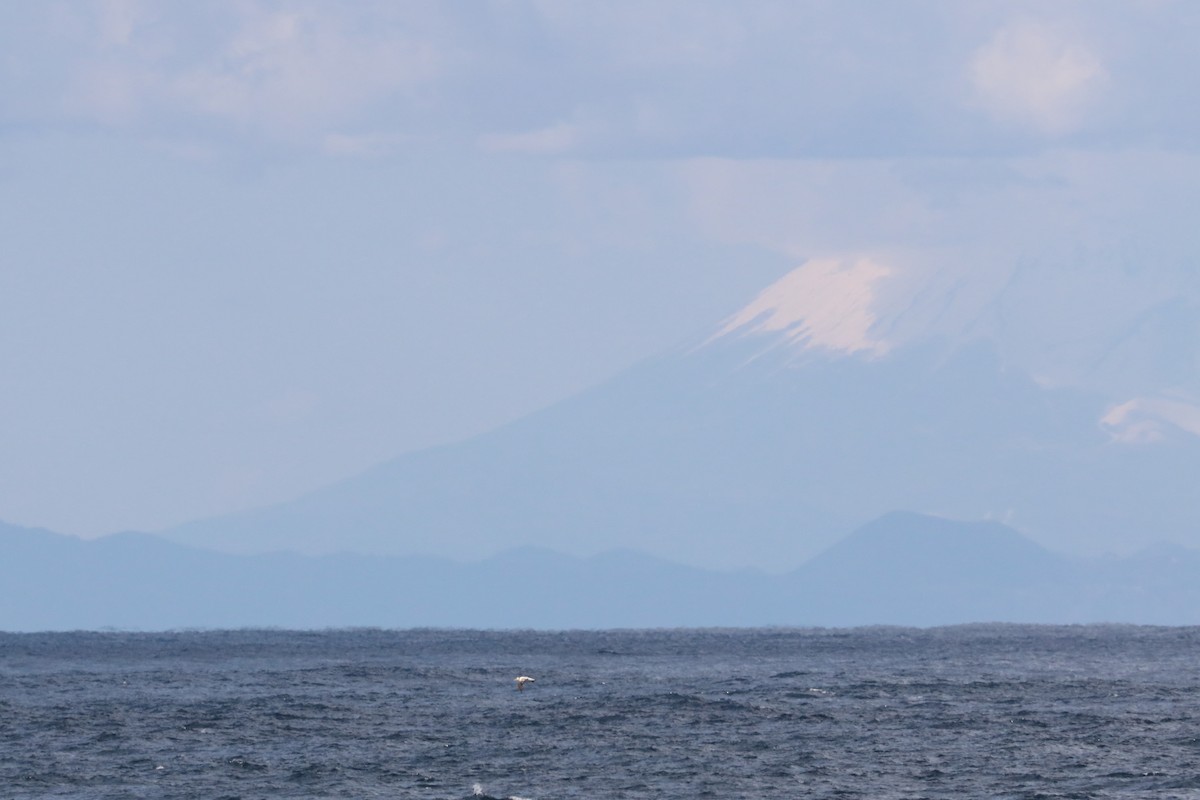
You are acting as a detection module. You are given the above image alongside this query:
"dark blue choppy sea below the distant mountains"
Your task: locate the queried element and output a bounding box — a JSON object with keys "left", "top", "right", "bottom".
{"left": 0, "top": 626, "right": 1200, "bottom": 800}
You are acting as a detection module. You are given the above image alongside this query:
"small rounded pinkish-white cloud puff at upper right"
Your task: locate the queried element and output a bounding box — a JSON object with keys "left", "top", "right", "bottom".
{"left": 970, "top": 22, "right": 1106, "bottom": 136}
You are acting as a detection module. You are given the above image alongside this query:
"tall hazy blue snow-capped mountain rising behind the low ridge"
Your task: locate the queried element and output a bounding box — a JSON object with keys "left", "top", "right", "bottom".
{"left": 164, "top": 261, "right": 1200, "bottom": 571}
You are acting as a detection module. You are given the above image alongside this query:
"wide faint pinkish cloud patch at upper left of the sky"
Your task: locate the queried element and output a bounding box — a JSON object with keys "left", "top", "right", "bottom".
{"left": 60, "top": 0, "right": 440, "bottom": 143}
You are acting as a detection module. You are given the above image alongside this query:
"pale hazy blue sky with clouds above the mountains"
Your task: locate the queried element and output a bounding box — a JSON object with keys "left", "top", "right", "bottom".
{"left": 0, "top": 0, "right": 1200, "bottom": 536}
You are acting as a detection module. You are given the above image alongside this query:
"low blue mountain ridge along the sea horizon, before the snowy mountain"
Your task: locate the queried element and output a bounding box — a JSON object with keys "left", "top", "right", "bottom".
{"left": 9, "top": 512, "right": 1200, "bottom": 631}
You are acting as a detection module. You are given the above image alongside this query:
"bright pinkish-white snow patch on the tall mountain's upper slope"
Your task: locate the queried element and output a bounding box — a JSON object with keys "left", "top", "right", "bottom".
{"left": 709, "top": 258, "right": 892, "bottom": 356}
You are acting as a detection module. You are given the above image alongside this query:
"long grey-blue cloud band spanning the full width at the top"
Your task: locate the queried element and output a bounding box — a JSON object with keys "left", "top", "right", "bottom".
{"left": 0, "top": 0, "right": 1200, "bottom": 158}
